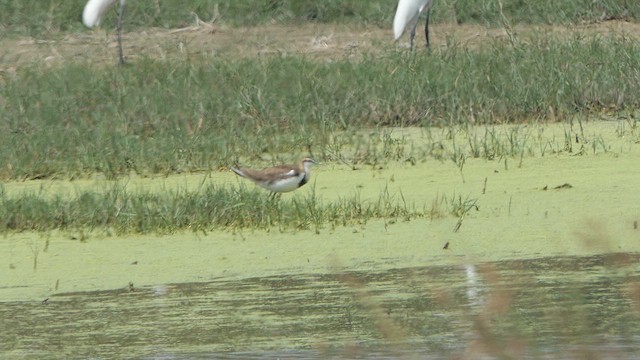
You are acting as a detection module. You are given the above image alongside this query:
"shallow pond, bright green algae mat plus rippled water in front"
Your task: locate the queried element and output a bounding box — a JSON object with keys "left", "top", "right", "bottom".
{"left": 0, "top": 123, "right": 640, "bottom": 359}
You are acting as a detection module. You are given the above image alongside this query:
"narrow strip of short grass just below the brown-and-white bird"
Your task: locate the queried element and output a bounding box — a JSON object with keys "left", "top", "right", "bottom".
{"left": 0, "top": 183, "right": 450, "bottom": 235}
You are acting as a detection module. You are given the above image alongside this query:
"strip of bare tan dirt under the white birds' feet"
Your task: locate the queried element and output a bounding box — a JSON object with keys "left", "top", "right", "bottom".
{"left": 0, "top": 21, "right": 640, "bottom": 73}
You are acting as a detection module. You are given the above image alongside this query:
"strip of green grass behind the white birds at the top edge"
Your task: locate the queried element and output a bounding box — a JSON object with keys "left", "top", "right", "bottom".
{"left": 0, "top": 0, "right": 640, "bottom": 38}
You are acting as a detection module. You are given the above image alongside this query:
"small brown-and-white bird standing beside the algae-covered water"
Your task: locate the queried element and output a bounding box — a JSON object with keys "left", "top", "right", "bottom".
{"left": 231, "top": 158, "right": 316, "bottom": 193}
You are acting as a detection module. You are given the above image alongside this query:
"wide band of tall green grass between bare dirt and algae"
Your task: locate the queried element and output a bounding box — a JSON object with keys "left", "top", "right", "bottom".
{"left": 0, "top": 37, "right": 640, "bottom": 179}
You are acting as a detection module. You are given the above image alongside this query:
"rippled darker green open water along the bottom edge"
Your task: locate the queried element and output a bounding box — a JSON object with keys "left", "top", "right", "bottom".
{"left": 0, "top": 254, "right": 640, "bottom": 359}
